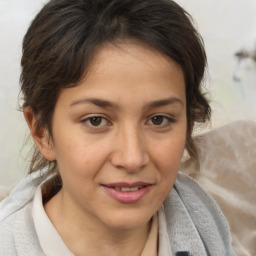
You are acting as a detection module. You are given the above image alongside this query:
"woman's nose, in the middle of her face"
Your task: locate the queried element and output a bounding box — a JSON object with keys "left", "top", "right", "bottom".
{"left": 111, "top": 128, "right": 149, "bottom": 172}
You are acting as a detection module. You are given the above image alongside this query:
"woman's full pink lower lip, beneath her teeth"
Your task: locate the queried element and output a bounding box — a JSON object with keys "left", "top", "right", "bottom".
{"left": 103, "top": 186, "right": 151, "bottom": 204}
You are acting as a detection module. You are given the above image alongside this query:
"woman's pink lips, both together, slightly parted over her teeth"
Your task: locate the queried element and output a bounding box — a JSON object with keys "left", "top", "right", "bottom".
{"left": 102, "top": 182, "right": 153, "bottom": 204}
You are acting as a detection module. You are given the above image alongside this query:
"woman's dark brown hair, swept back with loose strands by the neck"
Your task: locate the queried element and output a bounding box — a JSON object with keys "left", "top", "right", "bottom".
{"left": 21, "top": 0, "right": 210, "bottom": 181}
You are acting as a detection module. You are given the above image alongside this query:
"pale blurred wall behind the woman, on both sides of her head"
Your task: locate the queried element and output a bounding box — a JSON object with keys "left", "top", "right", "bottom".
{"left": 0, "top": 0, "right": 256, "bottom": 186}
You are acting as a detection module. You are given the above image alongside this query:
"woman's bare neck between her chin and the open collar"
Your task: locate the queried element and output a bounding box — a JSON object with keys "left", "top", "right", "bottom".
{"left": 44, "top": 188, "right": 151, "bottom": 256}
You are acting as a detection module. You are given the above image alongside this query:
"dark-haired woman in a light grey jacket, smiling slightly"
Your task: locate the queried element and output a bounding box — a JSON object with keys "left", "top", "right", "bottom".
{"left": 0, "top": 0, "right": 234, "bottom": 256}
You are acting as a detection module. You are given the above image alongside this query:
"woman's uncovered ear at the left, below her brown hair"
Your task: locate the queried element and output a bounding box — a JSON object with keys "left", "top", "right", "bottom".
{"left": 24, "top": 107, "right": 56, "bottom": 161}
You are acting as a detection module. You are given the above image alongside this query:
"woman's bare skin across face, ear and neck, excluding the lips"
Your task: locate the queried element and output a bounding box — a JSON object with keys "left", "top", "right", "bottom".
{"left": 25, "top": 43, "right": 187, "bottom": 256}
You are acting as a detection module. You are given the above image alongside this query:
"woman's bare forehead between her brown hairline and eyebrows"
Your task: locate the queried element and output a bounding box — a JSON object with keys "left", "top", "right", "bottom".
{"left": 57, "top": 43, "right": 185, "bottom": 108}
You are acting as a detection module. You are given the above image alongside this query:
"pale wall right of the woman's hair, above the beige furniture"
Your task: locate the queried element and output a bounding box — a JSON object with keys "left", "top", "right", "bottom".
{"left": 178, "top": 0, "right": 256, "bottom": 127}
